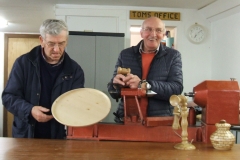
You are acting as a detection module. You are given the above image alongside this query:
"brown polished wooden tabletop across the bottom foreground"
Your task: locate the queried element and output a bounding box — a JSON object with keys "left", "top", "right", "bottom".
{"left": 0, "top": 137, "right": 240, "bottom": 160}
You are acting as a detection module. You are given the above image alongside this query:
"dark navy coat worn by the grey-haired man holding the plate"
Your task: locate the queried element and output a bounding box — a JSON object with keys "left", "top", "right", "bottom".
{"left": 2, "top": 46, "right": 84, "bottom": 139}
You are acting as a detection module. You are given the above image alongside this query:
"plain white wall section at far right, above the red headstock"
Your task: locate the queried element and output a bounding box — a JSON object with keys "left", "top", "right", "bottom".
{"left": 211, "top": 13, "right": 240, "bottom": 81}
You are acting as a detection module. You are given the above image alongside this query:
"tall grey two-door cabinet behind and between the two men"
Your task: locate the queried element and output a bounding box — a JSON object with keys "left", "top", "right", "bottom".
{"left": 66, "top": 31, "right": 124, "bottom": 122}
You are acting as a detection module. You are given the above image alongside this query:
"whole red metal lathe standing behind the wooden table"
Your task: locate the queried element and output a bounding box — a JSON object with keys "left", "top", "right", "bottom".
{"left": 67, "top": 81, "right": 239, "bottom": 143}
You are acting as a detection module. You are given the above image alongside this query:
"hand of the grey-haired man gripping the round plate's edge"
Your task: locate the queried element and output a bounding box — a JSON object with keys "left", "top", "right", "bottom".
{"left": 31, "top": 106, "right": 53, "bottom": 122}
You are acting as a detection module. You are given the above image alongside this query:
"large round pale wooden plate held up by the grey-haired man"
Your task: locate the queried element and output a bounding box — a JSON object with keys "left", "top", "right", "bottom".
{"left": 52, "top": 88, "right": 111, "bottom": 127}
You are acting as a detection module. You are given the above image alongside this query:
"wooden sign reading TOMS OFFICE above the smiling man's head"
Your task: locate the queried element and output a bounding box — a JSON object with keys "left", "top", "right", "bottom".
{"left": 130, "top": 11, "right": 180, "bottom": 21}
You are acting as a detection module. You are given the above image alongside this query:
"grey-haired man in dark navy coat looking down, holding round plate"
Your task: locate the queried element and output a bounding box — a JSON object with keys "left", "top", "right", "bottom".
{"left": 2, "top": 19, "right": 84, "bottom": 139}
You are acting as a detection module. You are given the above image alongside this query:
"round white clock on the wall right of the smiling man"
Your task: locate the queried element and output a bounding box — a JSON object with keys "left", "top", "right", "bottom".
{"left": 188, "top": 24, "right": 206, "bottom": 43}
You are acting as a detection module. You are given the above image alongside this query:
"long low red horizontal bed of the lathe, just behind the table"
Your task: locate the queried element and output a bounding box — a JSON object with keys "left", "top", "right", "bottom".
{"left": 67, "top": 123, "right": 202, "bottom": 142}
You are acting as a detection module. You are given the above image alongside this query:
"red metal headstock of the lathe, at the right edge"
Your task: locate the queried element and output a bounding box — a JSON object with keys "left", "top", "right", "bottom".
{"left": 185, "top": 81, "right": 239, "bottom": 143}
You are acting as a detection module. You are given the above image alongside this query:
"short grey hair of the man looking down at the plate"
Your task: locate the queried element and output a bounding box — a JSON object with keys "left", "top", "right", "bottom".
{"left": 39, "top": 19, "right": 68, "bottom": 39}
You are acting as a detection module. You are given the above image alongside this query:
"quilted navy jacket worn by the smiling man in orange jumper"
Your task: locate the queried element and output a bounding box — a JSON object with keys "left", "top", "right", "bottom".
{"left": 108, "top": 41, "right": 183, "bottom": 117}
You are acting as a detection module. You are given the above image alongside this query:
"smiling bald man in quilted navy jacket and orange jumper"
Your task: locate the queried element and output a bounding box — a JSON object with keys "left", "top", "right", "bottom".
{"left": 108, "top": 17, "right": 183, "bottom": 123}
